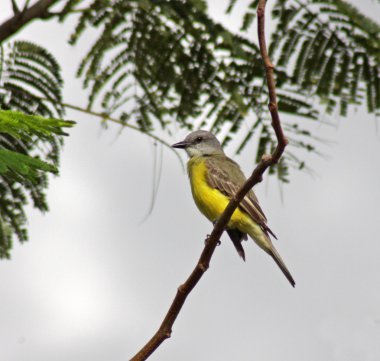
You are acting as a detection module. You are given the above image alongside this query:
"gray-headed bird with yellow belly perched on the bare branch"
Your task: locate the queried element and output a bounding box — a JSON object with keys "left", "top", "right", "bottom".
{"left": 172, "top": 130, "right": 295, "bottom": 287}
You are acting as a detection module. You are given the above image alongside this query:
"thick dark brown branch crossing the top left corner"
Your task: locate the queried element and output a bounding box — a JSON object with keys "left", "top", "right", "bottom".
{"left": 0, "top": 0, "right": 59, "bottom": 44}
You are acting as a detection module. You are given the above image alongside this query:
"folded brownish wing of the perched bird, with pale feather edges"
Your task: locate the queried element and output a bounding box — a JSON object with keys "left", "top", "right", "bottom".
{"left": 206, "top": 157, "right": 277, "bottom": 239}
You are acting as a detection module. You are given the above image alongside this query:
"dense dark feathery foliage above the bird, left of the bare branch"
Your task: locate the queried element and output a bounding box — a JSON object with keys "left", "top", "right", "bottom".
{"left": 71, "top": 0, "right": 316, "bottom": 180}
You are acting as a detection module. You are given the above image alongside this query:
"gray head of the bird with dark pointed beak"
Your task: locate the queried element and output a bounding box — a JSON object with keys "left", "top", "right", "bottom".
{"left": 172, "top": 130, "right": 224, "bottom": 158}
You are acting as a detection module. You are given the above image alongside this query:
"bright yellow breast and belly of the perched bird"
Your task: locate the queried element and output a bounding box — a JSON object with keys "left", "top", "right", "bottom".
{"left": 188, "top": 157, "right": 252, "bottom": 231}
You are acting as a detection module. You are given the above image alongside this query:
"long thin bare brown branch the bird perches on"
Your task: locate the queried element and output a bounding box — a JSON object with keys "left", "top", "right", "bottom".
{"left": 131, "top": 0, "right": 288, "bottom": 361}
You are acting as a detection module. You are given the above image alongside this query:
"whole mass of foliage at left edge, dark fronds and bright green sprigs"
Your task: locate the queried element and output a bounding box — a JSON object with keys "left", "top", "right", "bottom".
{"left": 0, "top": 41, "right": 72, "bottom": 258}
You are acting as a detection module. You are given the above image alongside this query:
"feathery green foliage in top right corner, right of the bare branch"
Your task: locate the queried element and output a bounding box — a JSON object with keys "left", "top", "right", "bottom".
{"left": 232, "top": 0, "right": 380, "bottom": 116}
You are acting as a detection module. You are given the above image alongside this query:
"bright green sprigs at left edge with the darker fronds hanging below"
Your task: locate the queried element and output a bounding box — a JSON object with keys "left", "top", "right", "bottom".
{"left": 0, "top": 110, "right": 73, "bottom": 258}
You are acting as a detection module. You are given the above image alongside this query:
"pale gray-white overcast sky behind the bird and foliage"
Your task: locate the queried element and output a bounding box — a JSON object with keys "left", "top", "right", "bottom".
{"left": 0, "top": 0, "right": 380, "bottom": 361}
